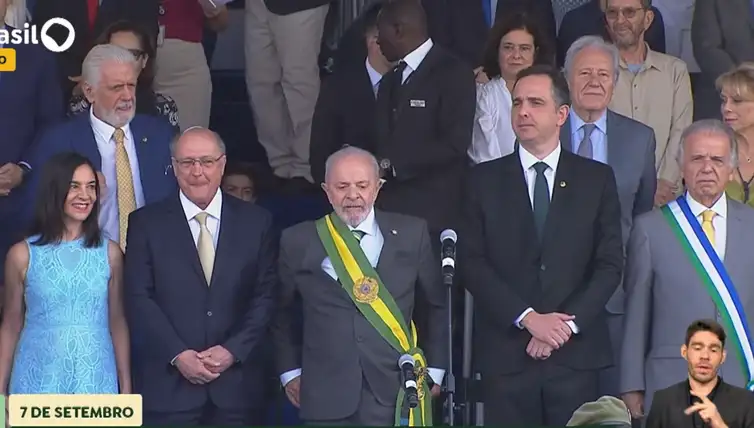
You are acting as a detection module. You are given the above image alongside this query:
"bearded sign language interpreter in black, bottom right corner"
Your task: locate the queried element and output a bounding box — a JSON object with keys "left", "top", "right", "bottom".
{"left": 646, "top": 320, "right": 754, "bottom": 428}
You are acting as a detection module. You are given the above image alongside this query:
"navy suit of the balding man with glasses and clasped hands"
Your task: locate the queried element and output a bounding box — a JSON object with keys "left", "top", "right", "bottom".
{"left": 124, "top": 194, "right": 277, "bottom": 426}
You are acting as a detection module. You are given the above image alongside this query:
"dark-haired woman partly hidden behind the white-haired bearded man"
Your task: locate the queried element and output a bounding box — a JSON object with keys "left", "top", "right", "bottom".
{"left": 68, "top": 21, "right": 178, "bottom": 132}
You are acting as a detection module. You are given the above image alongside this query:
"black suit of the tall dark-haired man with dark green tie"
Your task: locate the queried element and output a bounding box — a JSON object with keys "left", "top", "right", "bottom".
{"left": 458, "top": 149, "right": 623, "bottom": 426}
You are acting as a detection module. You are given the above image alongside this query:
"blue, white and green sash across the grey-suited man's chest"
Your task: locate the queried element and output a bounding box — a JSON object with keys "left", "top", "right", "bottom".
{"left": 661, "top": 195, "right": 754, "bottom": 391}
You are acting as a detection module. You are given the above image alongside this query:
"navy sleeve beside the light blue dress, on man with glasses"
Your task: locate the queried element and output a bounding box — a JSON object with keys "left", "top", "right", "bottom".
{"left": 123, "top": 210, "right": 188, "bottom": 366}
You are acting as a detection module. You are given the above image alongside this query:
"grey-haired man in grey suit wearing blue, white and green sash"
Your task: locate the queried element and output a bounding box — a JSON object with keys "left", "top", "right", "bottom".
{"left": 620, "top": 120, "right": 754, "bottom": 417}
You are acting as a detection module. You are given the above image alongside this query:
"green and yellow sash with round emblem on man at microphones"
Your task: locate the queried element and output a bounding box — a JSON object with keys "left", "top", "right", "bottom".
{"left": 316, "top": 213, "right": 432, "bottom": 426}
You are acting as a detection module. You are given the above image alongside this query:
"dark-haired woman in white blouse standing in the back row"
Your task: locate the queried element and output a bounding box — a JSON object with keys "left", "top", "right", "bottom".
{"left": 468, "top": 14, "right": 553, "bottom": 163}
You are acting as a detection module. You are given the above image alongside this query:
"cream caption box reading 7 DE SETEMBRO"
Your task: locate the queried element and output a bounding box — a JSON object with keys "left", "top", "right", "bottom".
{"left": 8, "top": 394, "right": 142, "bottom": 427}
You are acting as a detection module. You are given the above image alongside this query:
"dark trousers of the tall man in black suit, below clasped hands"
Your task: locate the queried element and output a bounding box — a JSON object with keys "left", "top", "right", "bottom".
{"left": 482, "top": 362, "right": 599, "bottom": 427}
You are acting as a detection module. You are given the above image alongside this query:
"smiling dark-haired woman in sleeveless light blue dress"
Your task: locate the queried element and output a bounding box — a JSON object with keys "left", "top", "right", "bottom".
{"left": 0, "top": 153, "right": 131, "bottom": 395}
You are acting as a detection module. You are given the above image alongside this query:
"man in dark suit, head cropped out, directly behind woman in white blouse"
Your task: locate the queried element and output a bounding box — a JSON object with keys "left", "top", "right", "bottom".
{"left": 440, "top": 0, "right": 556, "bottom": 68}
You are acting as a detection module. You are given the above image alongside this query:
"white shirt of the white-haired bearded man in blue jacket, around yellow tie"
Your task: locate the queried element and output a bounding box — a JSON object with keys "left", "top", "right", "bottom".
{"left": 89, "top": 109, "right": 144, "bottom": 242}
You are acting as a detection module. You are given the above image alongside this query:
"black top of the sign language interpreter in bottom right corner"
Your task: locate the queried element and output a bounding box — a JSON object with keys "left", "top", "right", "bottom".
{"left": 646, "top": 380, "right": 754, "bottom": 428}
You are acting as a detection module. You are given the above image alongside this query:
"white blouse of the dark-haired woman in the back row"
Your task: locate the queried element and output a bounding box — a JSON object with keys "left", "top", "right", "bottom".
{"left": 467, "top": 77, "right": 516, "bottom": 163}
